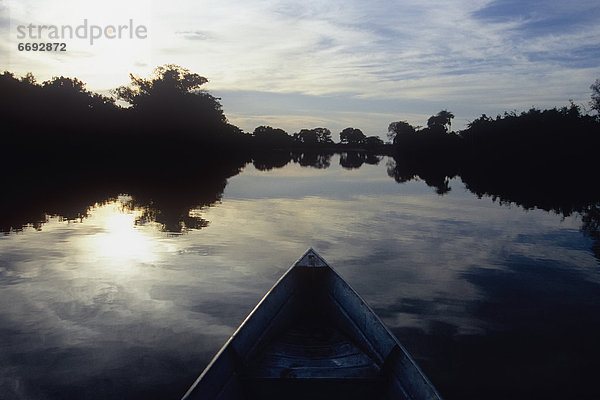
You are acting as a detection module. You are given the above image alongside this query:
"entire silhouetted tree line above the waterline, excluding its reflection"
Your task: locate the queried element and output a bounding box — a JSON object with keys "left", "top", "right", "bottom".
{"left": 0, "top": 64, "right": 600, "bottom": 154}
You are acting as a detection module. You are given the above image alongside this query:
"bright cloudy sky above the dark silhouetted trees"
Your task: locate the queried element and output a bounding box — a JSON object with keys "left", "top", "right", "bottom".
{"left": 0, "top": 0, "right": 600, "bottom": 139}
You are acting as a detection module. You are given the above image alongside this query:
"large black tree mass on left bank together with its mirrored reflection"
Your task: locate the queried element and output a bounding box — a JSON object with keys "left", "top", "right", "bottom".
{"left": 0, "top": 66, "right": 249, "bottom": 232}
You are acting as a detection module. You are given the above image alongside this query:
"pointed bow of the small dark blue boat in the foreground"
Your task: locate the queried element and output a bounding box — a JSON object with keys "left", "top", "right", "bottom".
{"left": 183, "top": 249, "right": 441, "bottom": 400}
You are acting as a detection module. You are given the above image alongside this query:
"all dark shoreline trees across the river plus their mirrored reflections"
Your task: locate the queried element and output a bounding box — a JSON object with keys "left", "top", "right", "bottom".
{"left": 0, "top": 65, "right": 600, "bottom": 254}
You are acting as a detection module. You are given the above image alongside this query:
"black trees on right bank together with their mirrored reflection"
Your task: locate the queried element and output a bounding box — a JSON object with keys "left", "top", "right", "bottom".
{"left": 388, "top": 104, "right": 600, "bottom": 258}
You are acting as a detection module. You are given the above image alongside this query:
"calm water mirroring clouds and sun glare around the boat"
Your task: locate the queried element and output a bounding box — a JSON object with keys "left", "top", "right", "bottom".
{"left": 0, "top": 156, "right": 600, "bottom": 399}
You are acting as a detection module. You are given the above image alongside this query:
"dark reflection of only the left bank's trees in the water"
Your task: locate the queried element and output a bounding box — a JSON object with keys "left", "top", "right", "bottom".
{"left": 0, "top": 158, "right": 246, "bottom": 233}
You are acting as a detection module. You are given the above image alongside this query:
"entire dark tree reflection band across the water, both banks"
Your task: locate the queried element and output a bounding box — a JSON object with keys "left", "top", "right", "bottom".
{"left": 0, "top": 150, "right": 600, "bottom": 259}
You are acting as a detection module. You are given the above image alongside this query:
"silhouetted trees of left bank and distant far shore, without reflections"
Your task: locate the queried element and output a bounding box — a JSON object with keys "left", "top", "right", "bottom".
{"left": 0, "top": 65, "right": 383, "bottom": 151}
